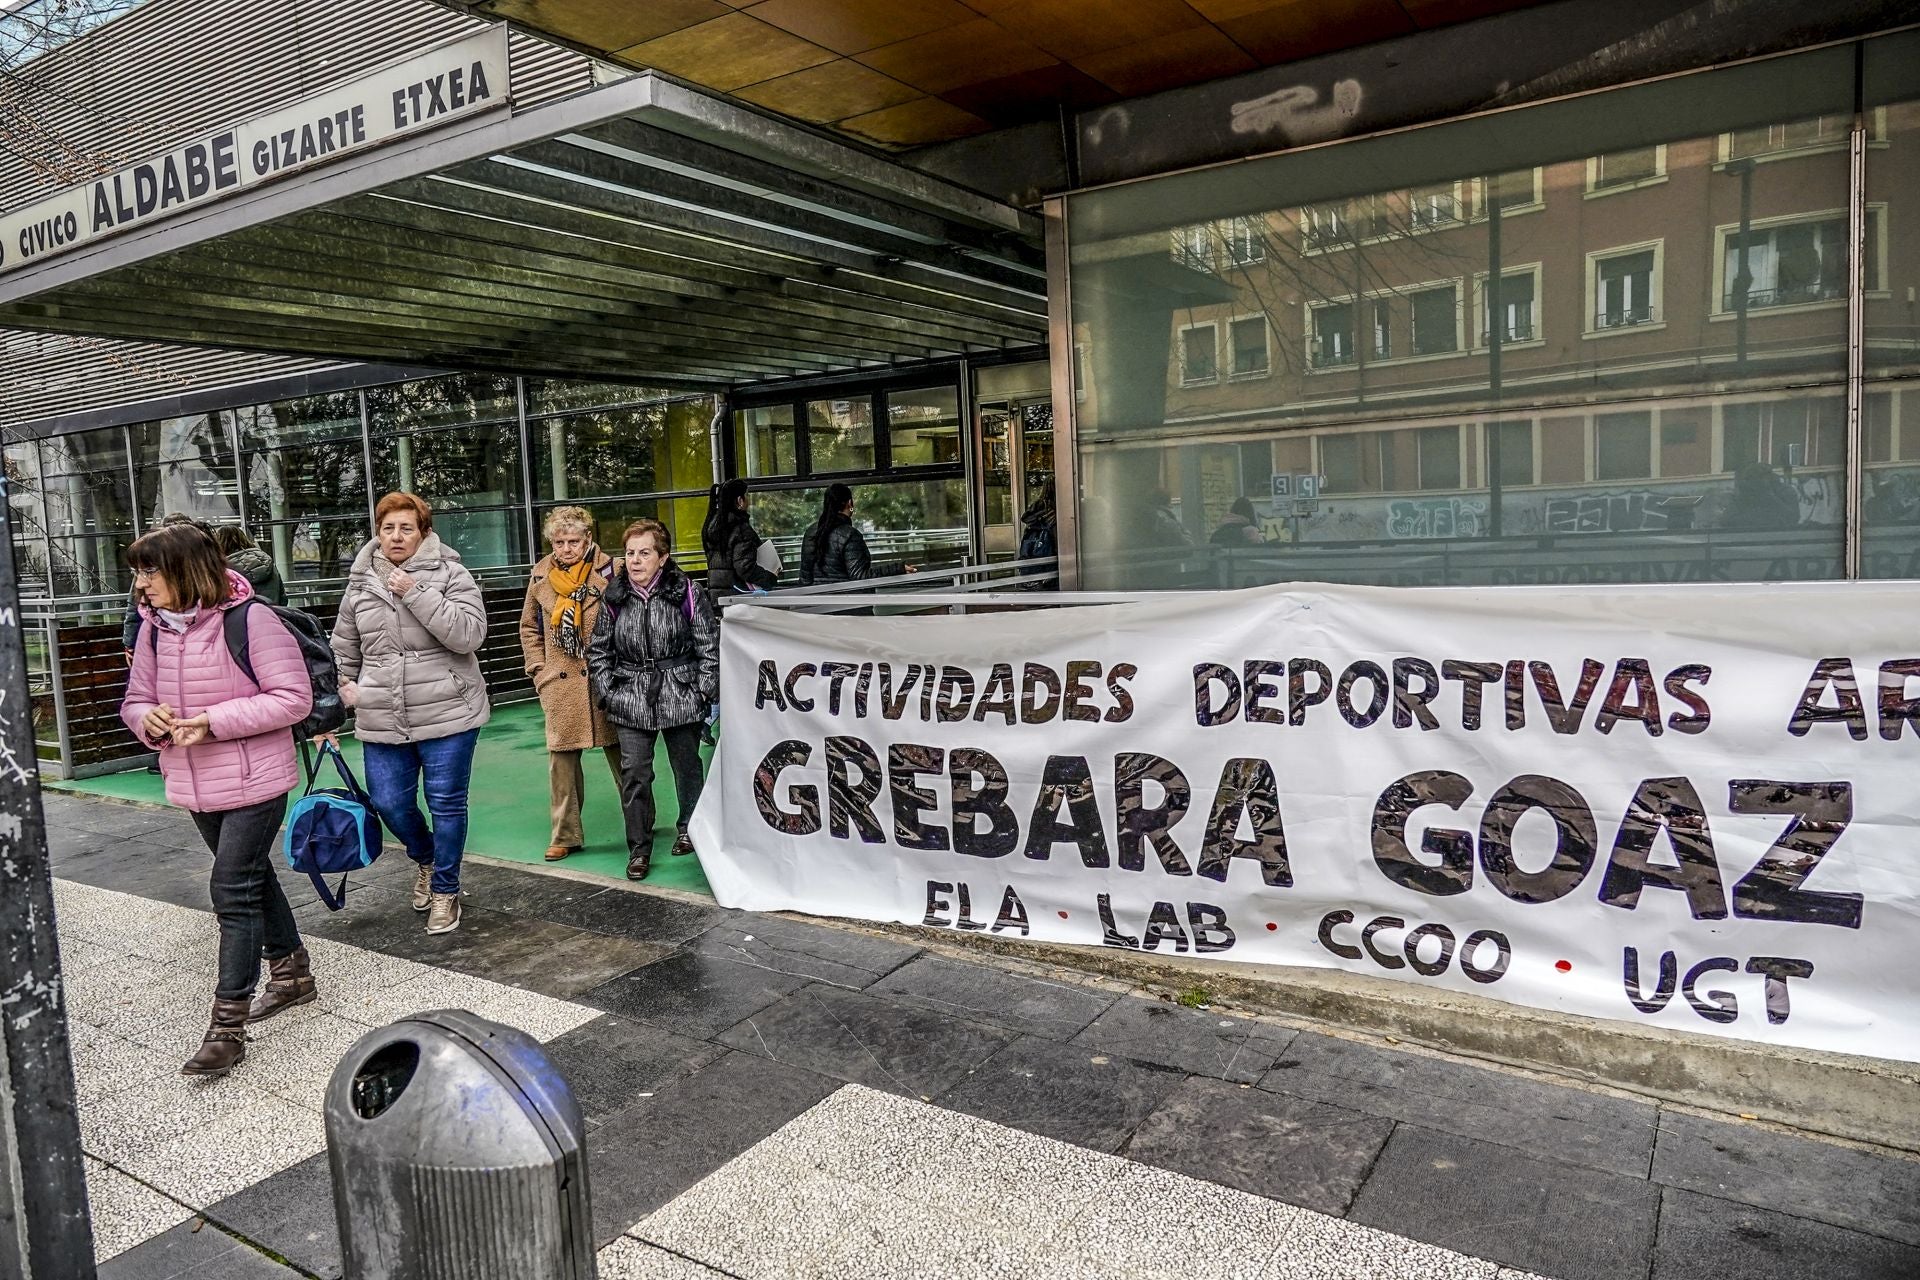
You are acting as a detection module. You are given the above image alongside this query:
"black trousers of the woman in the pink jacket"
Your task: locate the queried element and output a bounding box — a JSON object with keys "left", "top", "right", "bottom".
{"left": 194, "top": 796, "right": 300, "bottom": 1000}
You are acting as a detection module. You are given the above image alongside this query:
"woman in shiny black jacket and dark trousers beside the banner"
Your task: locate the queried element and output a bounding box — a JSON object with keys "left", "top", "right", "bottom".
{"left": 588, "top": 520, "right": 720, "bottom": 881}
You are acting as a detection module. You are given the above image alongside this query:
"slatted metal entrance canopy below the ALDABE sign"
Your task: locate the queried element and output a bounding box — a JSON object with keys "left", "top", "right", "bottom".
{"left": 0, "top": 73, "right": 1046, "bottom": 388}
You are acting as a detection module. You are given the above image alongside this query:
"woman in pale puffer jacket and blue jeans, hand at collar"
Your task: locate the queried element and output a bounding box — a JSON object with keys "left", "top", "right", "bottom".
{"left": 332, "top": 493, "right": 492, "bottom": 933}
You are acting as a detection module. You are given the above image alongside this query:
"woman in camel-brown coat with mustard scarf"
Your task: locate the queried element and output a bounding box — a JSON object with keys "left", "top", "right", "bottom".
{"left": 520, "top": 507, "right": 620, "bottom": 862}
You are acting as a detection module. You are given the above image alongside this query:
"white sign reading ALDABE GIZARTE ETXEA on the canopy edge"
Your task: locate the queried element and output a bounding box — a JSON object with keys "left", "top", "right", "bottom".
{"left": 0, "top": 27, "right": 507, "bottom": 273}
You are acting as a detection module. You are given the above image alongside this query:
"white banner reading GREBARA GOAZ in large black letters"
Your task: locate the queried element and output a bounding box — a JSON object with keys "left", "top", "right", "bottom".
{"left": 693, "top": 583, "right": 1920, "bottom": 1061}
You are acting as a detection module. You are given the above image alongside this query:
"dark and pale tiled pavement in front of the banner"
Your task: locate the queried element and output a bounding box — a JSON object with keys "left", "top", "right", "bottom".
{"left": 46, "top": 794, "right": 1920, "bottom": 1280}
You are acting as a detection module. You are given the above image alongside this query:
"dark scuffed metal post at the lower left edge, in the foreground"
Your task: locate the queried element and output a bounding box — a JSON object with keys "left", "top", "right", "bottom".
{"left": 0, "top": 477, "right": 94, "bottom": 1280}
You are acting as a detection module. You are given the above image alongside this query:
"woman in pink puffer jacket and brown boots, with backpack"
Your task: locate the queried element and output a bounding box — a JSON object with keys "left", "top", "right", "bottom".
{"left": 121, "top": 524, "right": 313, "bottom": 1075}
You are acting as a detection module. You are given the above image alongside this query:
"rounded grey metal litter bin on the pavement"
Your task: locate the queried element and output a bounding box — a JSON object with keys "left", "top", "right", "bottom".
{"left": 326, "top": 1009, "right": 595, "bottom": 1280}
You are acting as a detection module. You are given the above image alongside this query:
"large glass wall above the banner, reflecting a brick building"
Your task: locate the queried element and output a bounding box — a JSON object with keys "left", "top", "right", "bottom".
{"left": 1066, "top": 35, "right": 1920, "bottom": 589}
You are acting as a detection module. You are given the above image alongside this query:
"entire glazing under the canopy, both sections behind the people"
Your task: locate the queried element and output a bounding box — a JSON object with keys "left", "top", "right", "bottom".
{"left": 6, "top": 362, "right": 970, "bottom": 608}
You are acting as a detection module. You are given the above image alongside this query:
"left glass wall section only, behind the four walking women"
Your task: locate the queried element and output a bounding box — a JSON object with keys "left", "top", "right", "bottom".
{"left": 6, "top": 374, "right": 712, "bottom": 601}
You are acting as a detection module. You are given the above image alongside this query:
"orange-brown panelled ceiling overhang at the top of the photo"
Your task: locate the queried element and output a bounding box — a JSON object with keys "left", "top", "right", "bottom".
{"left": 440, "top": 0, "right": 1544, "bottom": 148}
